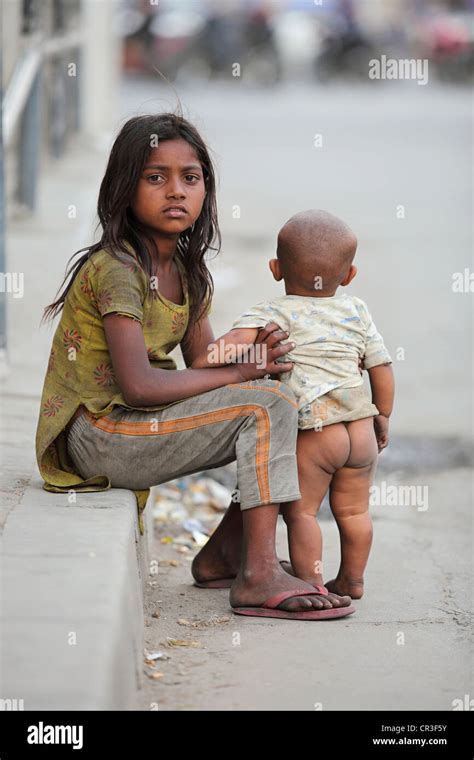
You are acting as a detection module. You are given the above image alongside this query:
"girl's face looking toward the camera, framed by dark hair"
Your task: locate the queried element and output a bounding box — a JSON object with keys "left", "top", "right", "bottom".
{"left": 130, "top": 138, "right": 206, "bottom": 235}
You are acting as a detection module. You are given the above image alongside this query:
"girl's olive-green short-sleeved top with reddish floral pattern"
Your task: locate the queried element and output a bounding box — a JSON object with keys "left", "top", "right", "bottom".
{"left": 36, "top": 245, "right": 202, "bottom": 532}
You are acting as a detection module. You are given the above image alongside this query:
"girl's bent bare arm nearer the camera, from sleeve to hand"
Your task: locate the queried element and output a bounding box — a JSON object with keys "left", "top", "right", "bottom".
{"left": 103, "top": 313, "right": 292, "bottom": 406}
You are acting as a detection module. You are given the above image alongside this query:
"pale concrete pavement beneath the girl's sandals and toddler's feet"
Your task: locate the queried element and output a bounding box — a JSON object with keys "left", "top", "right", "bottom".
{"left": 136, "top": 464, "right": 473, "bottom": 722}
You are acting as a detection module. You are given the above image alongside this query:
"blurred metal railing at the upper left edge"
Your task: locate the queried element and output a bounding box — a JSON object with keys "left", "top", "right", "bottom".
{"left": 0, "top": 0, "right": 84, "bottom": 368}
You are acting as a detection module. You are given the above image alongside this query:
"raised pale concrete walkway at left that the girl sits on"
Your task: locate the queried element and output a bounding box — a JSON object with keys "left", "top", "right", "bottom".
{"left": 0, "top": 134, "right": 151, "bottom": 710}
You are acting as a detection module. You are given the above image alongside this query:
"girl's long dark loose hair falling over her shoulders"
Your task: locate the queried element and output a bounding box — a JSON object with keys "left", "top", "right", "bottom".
{"left": 41, "top": 113, "right": 221, "bottom": 324}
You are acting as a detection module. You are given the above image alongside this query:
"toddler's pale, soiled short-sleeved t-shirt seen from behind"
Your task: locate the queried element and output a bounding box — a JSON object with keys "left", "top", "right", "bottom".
{"left": 232, "top": 294, "right": 392, "bottom": 427}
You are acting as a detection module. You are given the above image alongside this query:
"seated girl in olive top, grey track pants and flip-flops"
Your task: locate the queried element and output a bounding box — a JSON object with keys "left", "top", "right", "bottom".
{"left": 36, "top": 114, "right": 353, "bottom": 619}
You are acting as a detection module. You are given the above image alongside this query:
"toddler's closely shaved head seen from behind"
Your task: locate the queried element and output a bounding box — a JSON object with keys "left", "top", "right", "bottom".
{"left": 277, "top": 209, "right": 357, "bottom": 291}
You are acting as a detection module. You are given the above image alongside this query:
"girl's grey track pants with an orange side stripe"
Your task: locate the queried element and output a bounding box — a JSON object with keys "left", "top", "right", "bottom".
{"left": 67, "top": 379, "right": 301, "bottom": 509}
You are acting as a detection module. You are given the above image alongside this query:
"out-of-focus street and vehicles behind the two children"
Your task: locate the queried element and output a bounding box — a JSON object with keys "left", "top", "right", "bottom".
{"left": 0, "top": 0, "right": 474, "bottom": 439}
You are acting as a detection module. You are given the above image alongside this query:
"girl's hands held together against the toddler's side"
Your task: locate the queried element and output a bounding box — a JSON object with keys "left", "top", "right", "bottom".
{"left": 235, "top": 322, "right": 295, "bottom": 381}
